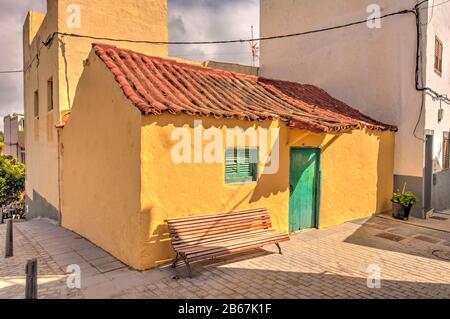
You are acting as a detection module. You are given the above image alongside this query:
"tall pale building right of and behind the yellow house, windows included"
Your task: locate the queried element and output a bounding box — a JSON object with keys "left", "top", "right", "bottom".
{"left": 260, "top": 0, "right": 450, "bottom": 216}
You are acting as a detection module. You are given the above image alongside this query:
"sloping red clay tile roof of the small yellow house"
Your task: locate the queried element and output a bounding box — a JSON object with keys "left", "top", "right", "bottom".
{"left": 93, "top": 44, "right": 396, "bottom": 132}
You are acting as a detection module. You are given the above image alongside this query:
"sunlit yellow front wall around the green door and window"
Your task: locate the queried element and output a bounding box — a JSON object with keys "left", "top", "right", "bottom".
{"left": 139, "top": 115, "right": 395, "bottom": 269}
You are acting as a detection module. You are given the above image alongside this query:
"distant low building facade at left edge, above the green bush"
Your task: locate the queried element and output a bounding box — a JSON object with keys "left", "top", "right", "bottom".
{"left": 3, "top": 114, "right": 25, "bottom": 164}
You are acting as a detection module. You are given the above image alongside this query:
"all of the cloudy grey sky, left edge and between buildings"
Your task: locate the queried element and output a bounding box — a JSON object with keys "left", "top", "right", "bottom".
{"left": 0, "top": 0, "right": 259, "bottom": 130}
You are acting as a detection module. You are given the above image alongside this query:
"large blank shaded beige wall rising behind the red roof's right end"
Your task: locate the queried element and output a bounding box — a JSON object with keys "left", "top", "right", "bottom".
{"left": 260, "top": 0, "right": 426, "bottom": 176}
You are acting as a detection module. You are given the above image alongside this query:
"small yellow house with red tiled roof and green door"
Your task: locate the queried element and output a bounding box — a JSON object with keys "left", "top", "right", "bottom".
{"left": 58, "top": 44, "right": 396, "bottom": 270}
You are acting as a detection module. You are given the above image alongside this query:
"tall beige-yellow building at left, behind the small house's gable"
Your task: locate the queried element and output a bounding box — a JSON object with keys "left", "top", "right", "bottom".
{"left": 23, "top": 0, "right": 168, "bottom": 220}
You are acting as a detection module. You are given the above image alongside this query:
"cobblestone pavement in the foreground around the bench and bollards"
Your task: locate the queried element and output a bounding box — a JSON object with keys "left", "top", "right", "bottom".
{"left": 0, "top": 215, "right": 450, "bottom": 299}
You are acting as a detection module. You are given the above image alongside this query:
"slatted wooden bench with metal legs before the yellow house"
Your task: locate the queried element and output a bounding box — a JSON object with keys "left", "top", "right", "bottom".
{"left": 166, "top": 209, "right": 289, "bottom": 278}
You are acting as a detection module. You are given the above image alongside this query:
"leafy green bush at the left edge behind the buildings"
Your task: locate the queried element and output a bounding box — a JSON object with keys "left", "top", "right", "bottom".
{"left": 0, "top": 154, "right": 25, "bottom": 207}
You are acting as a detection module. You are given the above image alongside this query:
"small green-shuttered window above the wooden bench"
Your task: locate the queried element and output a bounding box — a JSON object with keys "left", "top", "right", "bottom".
{"left": 225, "top": 148, "right": 258, "bottom": 184}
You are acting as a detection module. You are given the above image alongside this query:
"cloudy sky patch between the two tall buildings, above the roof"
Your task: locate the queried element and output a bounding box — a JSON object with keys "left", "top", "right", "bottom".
{"left": 169, "top": 0, "right": 259, "bottom": 65}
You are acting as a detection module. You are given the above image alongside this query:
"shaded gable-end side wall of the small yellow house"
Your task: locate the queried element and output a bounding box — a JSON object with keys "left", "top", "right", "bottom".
{"left": 62, "top": 53, "right": 141, "bottom": 268}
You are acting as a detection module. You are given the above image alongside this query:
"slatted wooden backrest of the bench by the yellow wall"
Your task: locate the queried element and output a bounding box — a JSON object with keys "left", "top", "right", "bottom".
{"left": 166, "top": 208, "right": 272, "bottom": 250}
